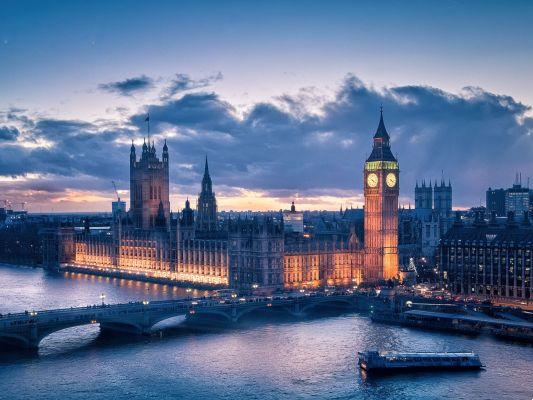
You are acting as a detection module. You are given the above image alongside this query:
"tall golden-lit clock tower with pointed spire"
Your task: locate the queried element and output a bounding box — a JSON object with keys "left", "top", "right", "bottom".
{"left": 364, "top": 109, "right": 400, "bottom": 282}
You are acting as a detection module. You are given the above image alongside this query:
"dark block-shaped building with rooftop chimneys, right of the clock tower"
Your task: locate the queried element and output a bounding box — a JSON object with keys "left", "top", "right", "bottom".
{"left": 439, "top": 211, "right": 533, "bottom": 299}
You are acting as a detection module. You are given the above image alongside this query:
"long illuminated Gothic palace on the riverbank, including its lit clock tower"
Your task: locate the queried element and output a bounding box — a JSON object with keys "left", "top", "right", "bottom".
{"left": 43, "top": 114, "right": 399, "bottom": 290}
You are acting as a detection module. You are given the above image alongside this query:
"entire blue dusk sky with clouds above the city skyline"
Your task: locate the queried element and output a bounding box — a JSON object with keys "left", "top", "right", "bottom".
{"left": 0, "top": 0, "right": 533, "bottom": 212}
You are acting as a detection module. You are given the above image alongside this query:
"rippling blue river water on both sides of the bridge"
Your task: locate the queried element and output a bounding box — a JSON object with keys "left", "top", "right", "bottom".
{"left": 0, "top": 265, "right": 533, "bottom": 400}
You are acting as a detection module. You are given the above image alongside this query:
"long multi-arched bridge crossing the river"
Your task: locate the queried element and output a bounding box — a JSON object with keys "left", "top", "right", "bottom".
{"left": 0, "top": 293, "right": 357, "bottom": 349}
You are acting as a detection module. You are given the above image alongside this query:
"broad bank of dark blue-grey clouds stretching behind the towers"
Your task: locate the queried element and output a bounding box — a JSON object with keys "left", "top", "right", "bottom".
{"left": 0, "top": 75, "right": 533, "bottom": 212}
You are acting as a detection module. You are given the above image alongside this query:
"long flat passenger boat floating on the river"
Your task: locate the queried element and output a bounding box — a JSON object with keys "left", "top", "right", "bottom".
{"left": 358, "top": 351, "right": 483, "bottom": 372}
